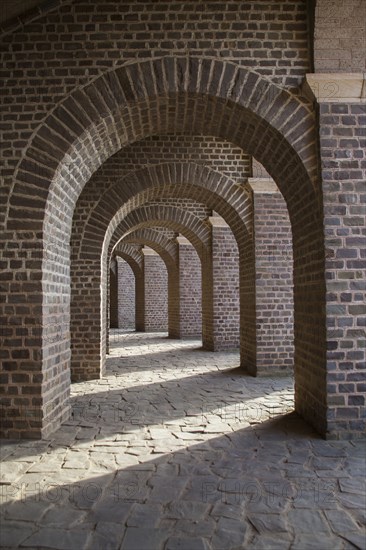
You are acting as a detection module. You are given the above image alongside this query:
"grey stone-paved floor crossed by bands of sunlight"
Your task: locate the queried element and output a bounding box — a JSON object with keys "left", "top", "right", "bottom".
{"left": 0, "top": 332, "right": 366, "bottom": 550}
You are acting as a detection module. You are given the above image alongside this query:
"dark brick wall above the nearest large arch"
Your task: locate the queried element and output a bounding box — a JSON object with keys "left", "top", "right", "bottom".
{"left": 0, "top": 0, "right": 309, "bottom": 238}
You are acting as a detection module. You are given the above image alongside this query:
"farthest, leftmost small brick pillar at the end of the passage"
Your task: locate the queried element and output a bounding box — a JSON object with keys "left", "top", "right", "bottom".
{"left": 118, "top": 258, "right": 136, "bottom": 329}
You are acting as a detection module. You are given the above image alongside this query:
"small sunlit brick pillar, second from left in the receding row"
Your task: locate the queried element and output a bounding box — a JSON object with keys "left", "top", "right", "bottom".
{"left": 142, "top": 247, "right": 168, "bottom": 332}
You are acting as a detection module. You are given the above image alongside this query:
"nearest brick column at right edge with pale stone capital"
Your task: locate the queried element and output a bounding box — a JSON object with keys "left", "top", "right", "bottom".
{"left": 307, "top": 73, "right": 366, "bottom": 439}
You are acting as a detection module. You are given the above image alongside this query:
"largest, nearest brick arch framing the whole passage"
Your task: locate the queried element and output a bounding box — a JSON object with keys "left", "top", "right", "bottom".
{"left": 0, "top": 57, "right": 327, "bottom": 442}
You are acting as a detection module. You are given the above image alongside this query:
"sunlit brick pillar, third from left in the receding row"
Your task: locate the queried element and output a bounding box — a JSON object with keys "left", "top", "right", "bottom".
{"left": 177, "top": 236, "right": 202, "bottom": 338}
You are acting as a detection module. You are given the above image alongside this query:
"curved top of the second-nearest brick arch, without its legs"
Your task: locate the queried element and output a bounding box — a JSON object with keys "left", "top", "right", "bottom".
{"left": 78, "top": 162, "right": 252, "bottom": 264}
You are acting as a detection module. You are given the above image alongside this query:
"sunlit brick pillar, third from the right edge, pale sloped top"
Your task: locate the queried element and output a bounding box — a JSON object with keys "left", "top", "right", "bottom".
{"left": 202, "top": 216, "right": 240, "bottom": 351}
